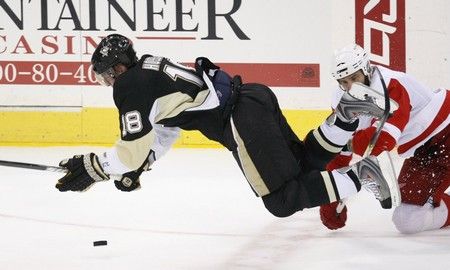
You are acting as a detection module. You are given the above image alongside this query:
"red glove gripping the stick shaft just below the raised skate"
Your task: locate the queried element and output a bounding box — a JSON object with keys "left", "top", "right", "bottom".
{"left": 351, "top": 127, "right": 396, "bottom": 156}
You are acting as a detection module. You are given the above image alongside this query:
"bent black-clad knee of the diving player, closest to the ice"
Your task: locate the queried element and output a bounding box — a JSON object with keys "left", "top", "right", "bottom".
{"left": 262, "top": 181, "right": 305, "bottom": 217}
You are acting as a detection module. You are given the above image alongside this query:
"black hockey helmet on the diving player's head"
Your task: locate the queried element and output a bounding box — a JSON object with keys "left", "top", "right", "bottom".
{"left": 91, "top": 34, "right": 138, "bottom": 84}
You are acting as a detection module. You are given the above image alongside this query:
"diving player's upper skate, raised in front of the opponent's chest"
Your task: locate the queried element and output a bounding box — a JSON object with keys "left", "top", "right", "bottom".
{"left": 336, "top": 82, "right": 398, "bottom": 121}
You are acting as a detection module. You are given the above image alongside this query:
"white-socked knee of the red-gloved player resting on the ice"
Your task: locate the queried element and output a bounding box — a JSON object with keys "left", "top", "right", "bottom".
{"left": 392, "top": 203, "right": 428, "bottom": 234}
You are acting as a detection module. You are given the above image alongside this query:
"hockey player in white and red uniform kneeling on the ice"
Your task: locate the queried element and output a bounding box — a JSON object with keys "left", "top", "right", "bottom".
{"left": 320, "top": 44, "right": 450, "bottom": 233}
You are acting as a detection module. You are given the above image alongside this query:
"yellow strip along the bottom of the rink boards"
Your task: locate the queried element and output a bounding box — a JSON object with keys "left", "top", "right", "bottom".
{"left": 0, "top": 108, "right": 330, "bottom": 148}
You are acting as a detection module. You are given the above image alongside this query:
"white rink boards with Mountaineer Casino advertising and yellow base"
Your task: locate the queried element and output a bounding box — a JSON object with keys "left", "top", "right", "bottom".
{"left": 0, "top": 0, "right": 450, "bottom": 147}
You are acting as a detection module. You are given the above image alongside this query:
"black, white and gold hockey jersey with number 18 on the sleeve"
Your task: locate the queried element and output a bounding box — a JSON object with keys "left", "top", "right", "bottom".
{"left": 99, "top": 55, "right": 224, "bottom": 174}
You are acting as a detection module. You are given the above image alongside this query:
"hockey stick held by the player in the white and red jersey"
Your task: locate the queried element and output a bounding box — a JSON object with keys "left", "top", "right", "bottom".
{"left": 336, "top": 66, "right": 391, "bottom": 213}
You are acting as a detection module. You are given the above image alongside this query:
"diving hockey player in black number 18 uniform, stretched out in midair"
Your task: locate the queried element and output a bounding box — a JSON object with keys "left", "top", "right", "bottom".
{"left": 56, "top": 34, "right": 390, "bottom": 217}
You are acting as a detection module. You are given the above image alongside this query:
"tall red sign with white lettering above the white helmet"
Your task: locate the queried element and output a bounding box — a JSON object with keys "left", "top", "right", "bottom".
{"left": 355, "top": 0, "right": 406, "bottom": 71}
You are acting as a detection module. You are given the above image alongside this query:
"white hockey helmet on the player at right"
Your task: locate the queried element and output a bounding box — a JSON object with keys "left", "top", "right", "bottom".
{"left": 331, "top": 44, "right": 371, "bottom": 80}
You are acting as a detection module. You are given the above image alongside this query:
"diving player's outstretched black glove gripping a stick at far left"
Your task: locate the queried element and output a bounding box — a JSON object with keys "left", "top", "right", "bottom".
{"left": 55, "top": 153, "right": 109, "bottom": 192}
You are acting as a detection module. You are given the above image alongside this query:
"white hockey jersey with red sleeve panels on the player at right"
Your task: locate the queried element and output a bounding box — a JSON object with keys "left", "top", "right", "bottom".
{"left": 332, "top": 66, "right": 450, "bottom": 158}
